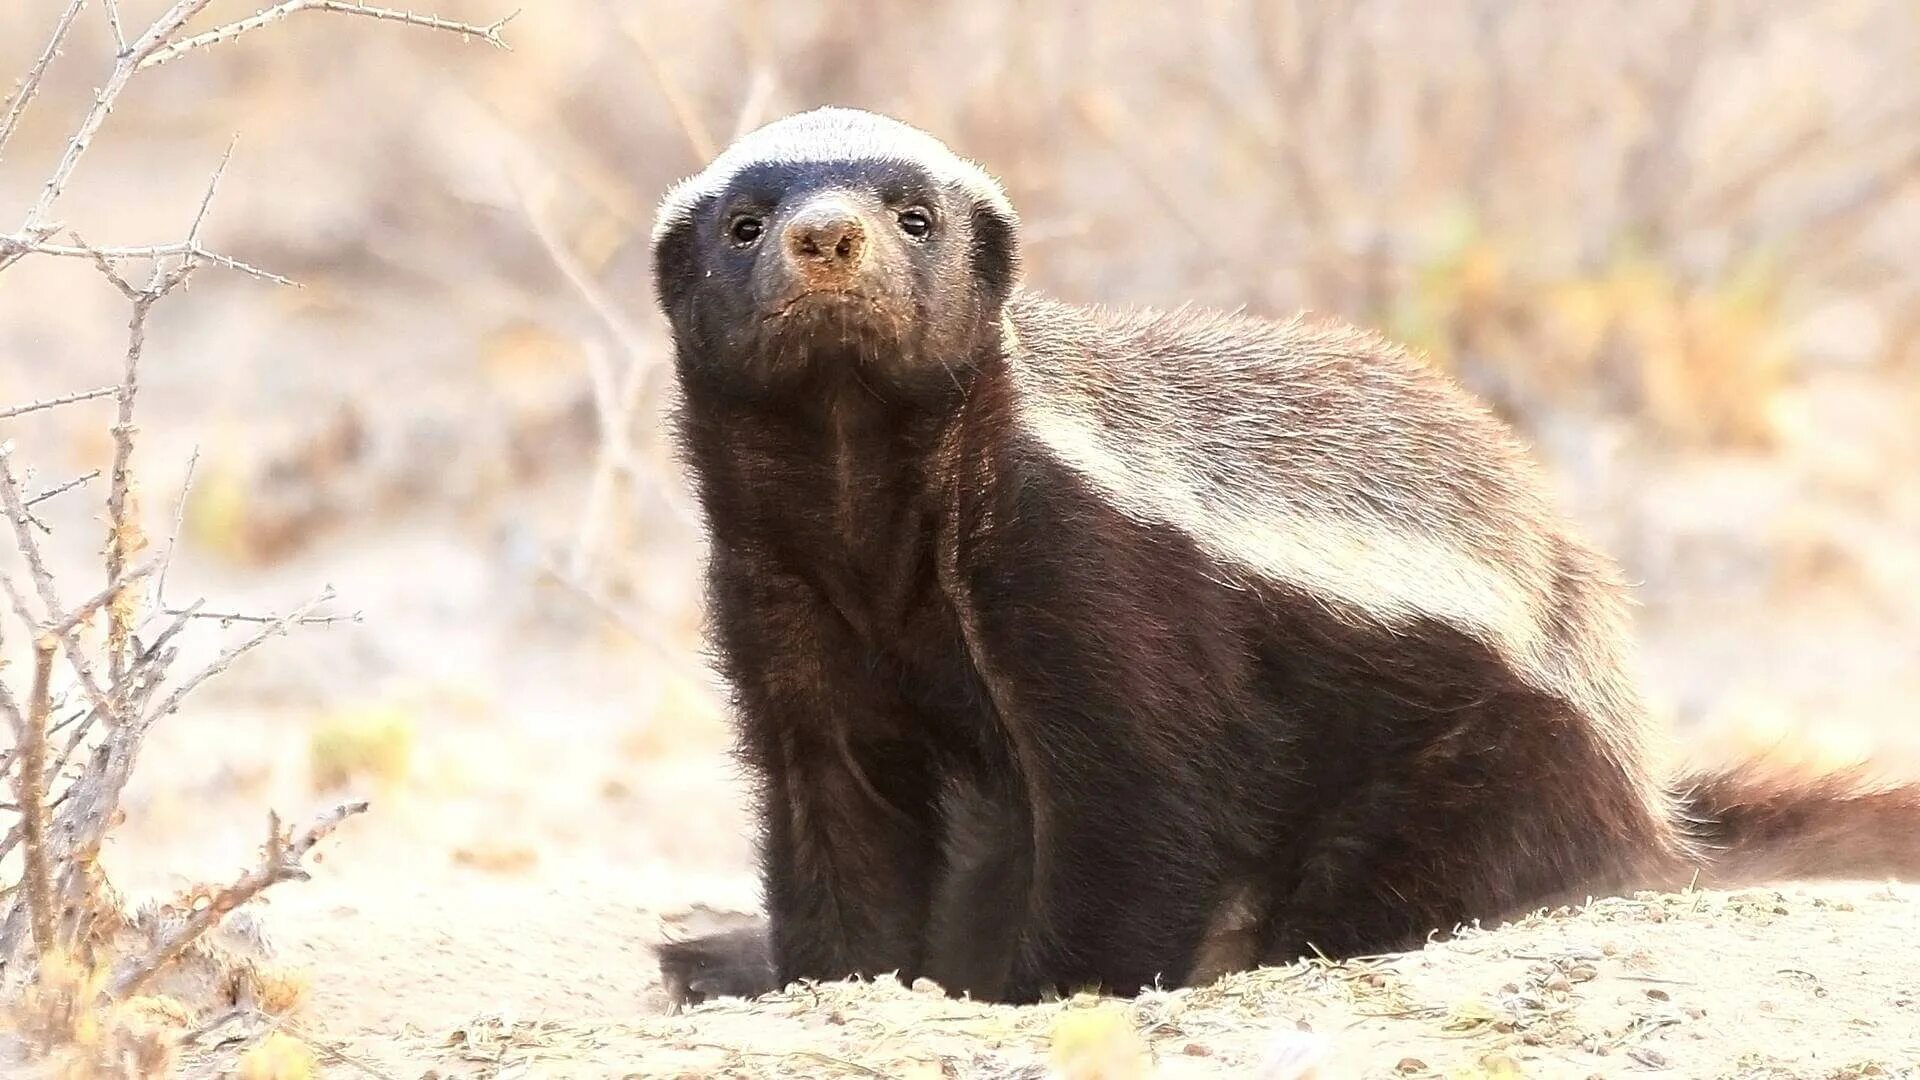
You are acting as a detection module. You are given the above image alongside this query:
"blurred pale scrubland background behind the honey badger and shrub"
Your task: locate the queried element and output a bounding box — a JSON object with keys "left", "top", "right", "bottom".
{"left": 0, "top": 0, "right": 1920, "bottom": 1022}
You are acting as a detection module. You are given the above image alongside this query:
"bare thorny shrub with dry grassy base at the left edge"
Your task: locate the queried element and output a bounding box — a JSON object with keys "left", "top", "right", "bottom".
{"left": 0, "top": 0, "right": 505, "bottom": 1076}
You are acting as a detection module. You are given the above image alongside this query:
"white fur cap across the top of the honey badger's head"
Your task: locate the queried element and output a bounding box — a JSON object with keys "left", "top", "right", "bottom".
{"left": 653, "top": 106, "right": 1018, "bottom": 244}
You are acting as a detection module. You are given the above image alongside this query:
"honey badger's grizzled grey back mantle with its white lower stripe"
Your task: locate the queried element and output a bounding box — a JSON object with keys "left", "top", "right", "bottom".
{"left": 1006, "top": 292, "right": 1640, "bottom": 745}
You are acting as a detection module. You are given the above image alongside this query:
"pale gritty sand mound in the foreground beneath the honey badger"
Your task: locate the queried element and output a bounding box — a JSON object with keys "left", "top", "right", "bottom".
{"left": 416, "top": 888, "right": 1920, "bottom": 1078}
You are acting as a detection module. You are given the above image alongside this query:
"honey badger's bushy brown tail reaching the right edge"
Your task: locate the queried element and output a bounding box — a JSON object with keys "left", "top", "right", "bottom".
{"left": 1678, "top": 759, "right": 1920, "bottom": 888}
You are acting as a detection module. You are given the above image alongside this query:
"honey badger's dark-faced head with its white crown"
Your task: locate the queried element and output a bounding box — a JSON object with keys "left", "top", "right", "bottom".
{"left": 653, "top": 108, "right": 1018, "bottom": 407}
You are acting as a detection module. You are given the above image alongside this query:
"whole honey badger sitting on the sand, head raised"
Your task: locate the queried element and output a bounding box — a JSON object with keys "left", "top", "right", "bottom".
{"left": 653, "top": 108, "right": 1920, "bottom": 1001}
